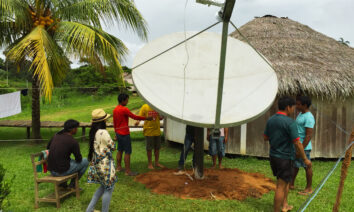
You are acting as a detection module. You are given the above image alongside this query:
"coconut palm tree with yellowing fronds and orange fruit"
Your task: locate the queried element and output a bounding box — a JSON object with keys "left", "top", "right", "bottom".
{"left": 0, "top": 0, "right": 147, "bottom": 138}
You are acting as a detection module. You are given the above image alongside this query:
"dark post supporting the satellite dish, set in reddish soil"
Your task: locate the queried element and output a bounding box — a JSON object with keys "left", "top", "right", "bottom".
{"left": 194, "top": 127, "right": 204, "bottom": 179}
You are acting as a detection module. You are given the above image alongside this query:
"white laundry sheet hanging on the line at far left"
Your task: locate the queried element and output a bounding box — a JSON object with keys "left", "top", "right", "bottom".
{"left": 0, "top": 91, "right": 21, "bottom": 118}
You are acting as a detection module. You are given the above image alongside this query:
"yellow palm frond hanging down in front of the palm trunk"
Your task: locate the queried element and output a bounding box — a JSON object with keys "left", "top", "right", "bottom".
{"left": 6, "top": 26, "right": 69, "bottom": 101}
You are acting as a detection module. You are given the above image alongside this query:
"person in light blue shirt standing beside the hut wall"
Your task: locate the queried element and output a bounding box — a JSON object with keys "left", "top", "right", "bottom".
{"left": 290, "top": 96, "right": 315, "bottom": 195}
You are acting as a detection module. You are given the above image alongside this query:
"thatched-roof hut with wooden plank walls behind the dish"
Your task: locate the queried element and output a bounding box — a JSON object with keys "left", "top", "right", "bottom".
{"left": 165, "top": 16, "right": 354, "bottom": 158}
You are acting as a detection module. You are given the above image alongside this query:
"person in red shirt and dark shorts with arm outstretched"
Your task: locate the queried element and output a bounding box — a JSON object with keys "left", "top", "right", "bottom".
{"left": 113, "top": 93, "right": 152, "bottom": 176}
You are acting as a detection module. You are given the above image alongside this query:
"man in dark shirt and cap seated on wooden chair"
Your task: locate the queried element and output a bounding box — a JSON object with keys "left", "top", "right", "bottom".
{"left": 47, "top": 119, "right": 88, "bottom": 187}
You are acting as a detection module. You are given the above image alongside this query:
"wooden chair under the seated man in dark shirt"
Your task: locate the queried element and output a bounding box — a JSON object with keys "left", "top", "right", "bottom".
{"left": 31, "top": 152, "right": 80, "bottom": 208}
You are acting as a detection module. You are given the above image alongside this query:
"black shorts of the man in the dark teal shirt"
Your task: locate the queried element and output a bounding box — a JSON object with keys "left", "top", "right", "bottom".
{"left": 269, "top": 156, "right": 294, "bottom": 183}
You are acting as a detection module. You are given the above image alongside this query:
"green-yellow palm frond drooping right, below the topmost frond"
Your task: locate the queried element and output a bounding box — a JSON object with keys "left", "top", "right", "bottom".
{"left": 54, "top": 22, "right": 127, "bottom": 85}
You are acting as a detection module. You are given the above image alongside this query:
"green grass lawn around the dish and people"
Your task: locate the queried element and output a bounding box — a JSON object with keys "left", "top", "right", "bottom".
{"left": 0, "top": 96, "right": 354, "bottom": 212}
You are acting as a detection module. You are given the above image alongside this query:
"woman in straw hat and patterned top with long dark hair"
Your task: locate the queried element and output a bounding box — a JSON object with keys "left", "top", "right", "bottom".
{"left": 86, "top": 109, "right": 117, "bottom": 212}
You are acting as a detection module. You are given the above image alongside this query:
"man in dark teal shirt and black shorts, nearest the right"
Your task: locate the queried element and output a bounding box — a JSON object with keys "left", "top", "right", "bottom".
{"left": 264, "top": 97, "right": 311, "bottom": 212}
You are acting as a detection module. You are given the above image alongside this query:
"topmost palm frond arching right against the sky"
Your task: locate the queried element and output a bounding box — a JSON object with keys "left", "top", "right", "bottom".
{"left": 54, "top": 0, "right": 148, "bottom": 40}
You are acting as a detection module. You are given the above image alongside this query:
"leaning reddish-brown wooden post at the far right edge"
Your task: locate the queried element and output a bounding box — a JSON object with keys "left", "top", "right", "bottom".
{"left": 333, "top": 128, "right": 354, "bottom": 212}
